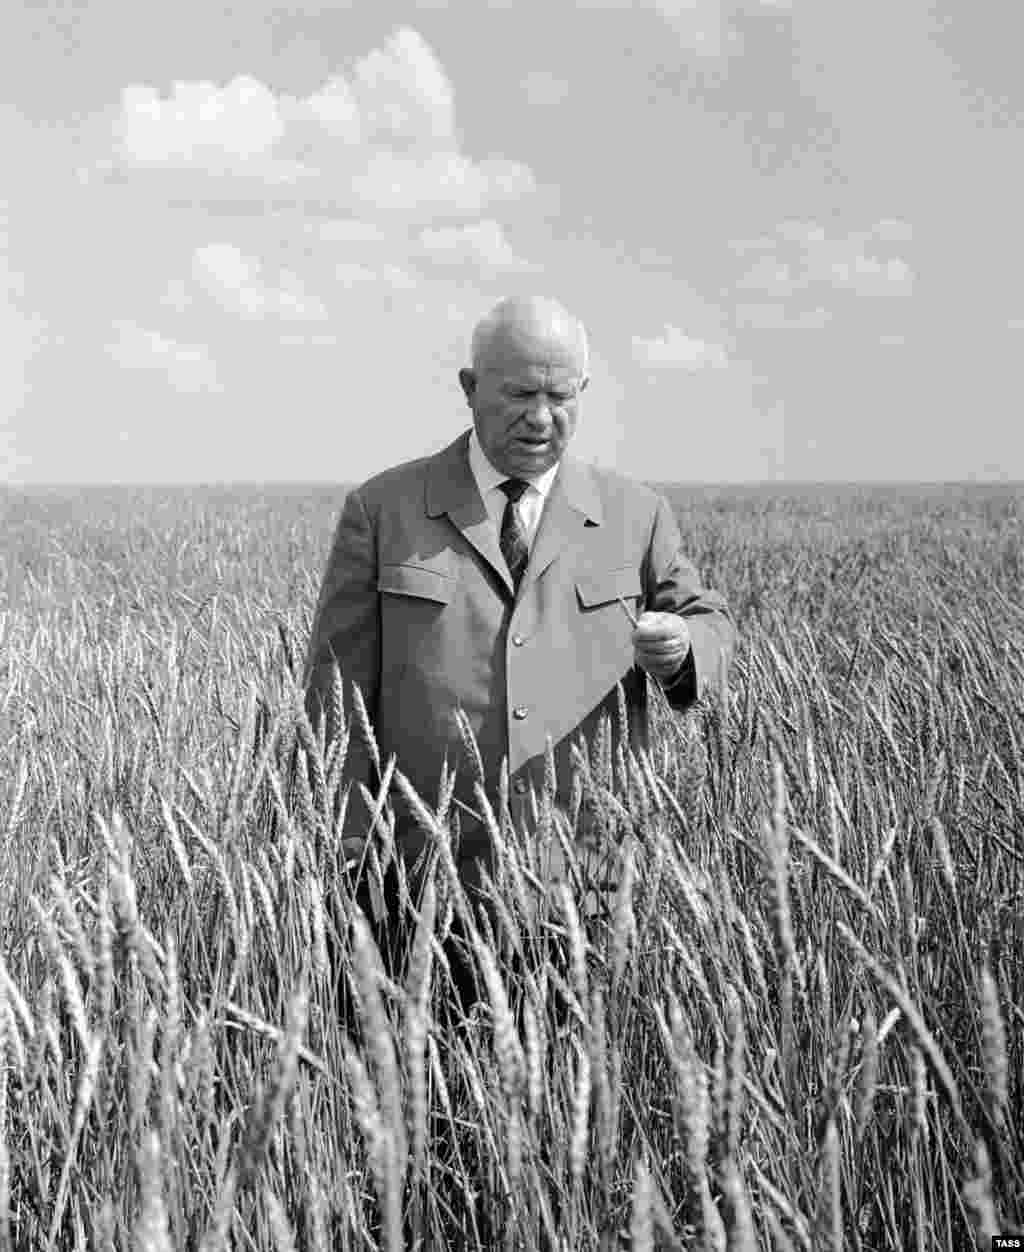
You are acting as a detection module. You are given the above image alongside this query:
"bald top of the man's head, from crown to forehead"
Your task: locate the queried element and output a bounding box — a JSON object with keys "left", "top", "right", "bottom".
{"left": 472, "top": 295, "right": 590, "bottom": 381}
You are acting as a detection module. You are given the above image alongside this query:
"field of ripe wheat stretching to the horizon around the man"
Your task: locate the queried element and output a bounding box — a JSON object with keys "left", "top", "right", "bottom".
{"left": 0, "top": 487, "right": 1024, "bottom": 1252}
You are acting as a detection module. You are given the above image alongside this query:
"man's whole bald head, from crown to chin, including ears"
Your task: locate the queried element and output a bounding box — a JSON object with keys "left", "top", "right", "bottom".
{"left": 458, "top": 295, "right": 588, "bottom": 478}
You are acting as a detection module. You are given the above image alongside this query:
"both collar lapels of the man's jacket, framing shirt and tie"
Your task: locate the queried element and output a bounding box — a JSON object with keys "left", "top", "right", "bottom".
{"left": 427, "top": 431, "right": 602, "bottom": 596}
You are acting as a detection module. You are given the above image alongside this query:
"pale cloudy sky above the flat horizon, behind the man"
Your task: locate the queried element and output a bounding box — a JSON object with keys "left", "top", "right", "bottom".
{"left": 0, "top": 0, "right": 1024, "bottom": 485}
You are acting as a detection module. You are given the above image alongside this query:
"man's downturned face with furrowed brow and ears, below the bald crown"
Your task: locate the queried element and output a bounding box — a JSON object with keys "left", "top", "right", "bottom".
{"left": 459, "top": 337, "right": 587, "bottom": 478}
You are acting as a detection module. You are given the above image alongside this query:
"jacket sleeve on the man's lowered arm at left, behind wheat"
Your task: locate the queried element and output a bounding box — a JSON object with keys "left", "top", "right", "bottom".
{"left": 303, "top": 490, "right": 381, "bottom": 838}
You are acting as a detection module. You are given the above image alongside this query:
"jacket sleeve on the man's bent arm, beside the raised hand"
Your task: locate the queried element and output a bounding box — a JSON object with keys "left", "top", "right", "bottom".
{"left": 643, "top": 496, "right": 736, "bottom": 709}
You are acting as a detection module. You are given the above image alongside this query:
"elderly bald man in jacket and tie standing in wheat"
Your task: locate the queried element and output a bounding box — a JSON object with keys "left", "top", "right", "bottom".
{"left": 304, "top": 298, "right": 734, "bottom": 941}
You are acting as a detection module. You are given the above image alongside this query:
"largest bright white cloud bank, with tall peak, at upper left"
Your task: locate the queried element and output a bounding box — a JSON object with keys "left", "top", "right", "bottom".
{"left": 86, "top": 28, "right": 536, "bottom": 222}
